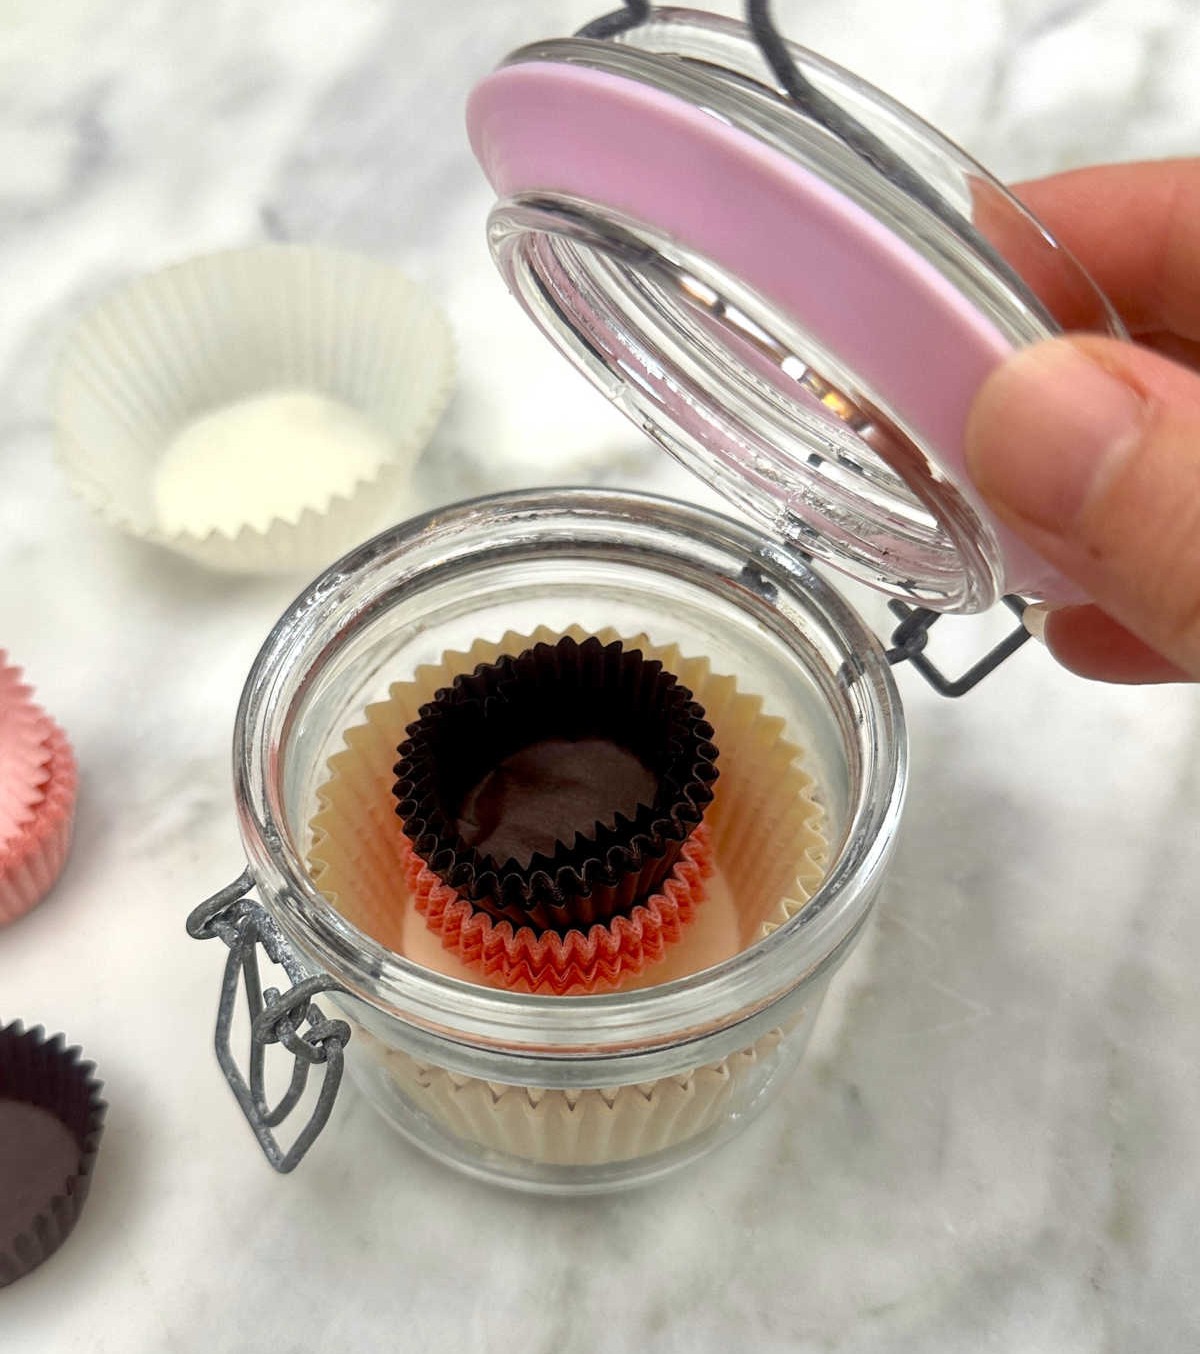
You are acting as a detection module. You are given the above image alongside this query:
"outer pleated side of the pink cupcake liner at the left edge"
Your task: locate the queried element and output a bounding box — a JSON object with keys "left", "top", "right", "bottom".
{"left": 0, "top": 720, "right": 79, "bottom": 926}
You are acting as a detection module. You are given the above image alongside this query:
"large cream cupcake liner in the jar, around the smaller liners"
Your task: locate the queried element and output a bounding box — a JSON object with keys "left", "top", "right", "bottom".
{"left": 309, "top": 627, "right": 828, "bottom": 1166}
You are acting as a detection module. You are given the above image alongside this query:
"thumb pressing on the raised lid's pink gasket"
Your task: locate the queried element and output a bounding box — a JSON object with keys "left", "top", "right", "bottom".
{"left": 967, "top": 337, "right": 1200, "bottom": 677}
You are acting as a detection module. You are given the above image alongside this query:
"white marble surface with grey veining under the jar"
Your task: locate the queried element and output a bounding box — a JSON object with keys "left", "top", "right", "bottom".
{"left": 0, "top": 0, "right": 1200, "bottom": 1354}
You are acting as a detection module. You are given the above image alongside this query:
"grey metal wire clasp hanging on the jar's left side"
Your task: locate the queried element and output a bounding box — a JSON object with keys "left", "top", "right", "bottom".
{"left": 187, "top": 871, "right": 349, "bottom": 1174}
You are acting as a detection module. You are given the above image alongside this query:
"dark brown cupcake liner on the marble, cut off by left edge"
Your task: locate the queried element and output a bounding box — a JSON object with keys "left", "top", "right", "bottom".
{"left": 0, "top": 1021, "right": 107, "bottom": 1288}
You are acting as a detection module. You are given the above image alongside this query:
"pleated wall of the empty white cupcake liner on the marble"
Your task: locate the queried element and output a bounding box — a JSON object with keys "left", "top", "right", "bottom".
{"left": 54, "top": 245, "right": 454, "bottom": 573}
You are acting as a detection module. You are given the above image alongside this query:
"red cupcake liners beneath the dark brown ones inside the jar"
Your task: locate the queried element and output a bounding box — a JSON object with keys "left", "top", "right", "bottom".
{"left": 400, "top": 823, "right": 712, "bottom": 997}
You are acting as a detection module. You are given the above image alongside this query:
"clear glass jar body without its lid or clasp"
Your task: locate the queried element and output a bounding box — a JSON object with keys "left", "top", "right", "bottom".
{"left": 234, "top": 490, "right": 906, "bottom": 1193}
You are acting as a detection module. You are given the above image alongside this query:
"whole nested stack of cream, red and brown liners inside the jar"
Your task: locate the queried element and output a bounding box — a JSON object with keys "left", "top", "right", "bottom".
{"left": 310, "top": 628, "right": 828, "bottom": 1167}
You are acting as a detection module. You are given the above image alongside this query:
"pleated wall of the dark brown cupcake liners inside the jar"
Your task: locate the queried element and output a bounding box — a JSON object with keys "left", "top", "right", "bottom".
{"left": 394, "top": 636, "right": 718, "bottom": 934}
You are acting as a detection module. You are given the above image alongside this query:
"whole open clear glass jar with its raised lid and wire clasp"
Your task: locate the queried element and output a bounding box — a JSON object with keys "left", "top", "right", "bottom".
{"left": 188, "top": 9, "right": 1121, "bottom": 1193}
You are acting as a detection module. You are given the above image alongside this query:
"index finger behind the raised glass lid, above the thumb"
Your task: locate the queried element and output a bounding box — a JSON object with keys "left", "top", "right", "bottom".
{"left": 1013, "top": 160, "right": 1200, "bottom": 341}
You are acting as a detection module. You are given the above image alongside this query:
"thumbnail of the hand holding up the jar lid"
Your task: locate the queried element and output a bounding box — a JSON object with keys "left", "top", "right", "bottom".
{"left": 967, "top": 339, "right": 1146, "bottom": 532}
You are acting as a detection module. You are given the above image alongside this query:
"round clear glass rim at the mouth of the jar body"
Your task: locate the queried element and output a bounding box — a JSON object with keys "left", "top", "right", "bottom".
{"left": 233, "top": 489, "right": 907, "bottom": 1056}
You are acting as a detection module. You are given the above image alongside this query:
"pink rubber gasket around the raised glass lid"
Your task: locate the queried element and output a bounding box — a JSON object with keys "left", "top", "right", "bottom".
{"left": 467, "top": 62, "right": 1079, "bottom": 601}
